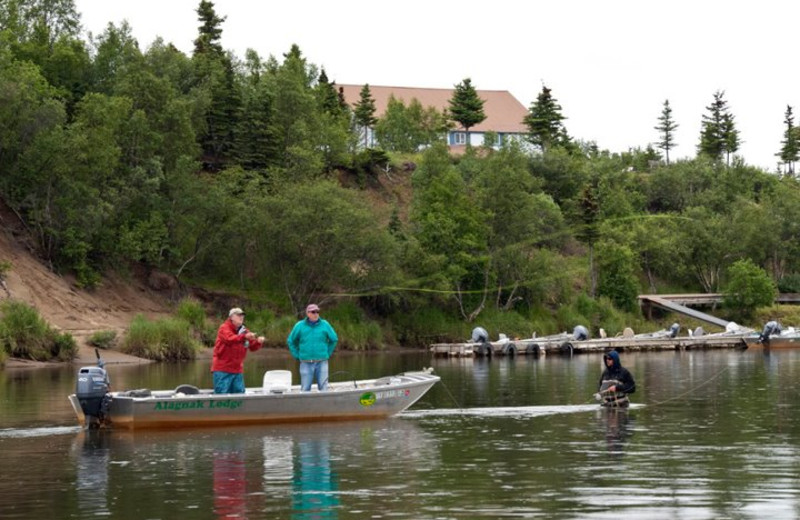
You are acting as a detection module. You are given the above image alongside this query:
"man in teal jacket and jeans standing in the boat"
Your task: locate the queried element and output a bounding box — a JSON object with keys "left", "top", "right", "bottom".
{"left": 286, "top": 303, "right": 339, "bottom": 392}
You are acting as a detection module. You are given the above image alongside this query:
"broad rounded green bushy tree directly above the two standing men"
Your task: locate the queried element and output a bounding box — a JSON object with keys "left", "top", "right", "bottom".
{"left": 253, "top": 181, "right": 394, "bottom": 313}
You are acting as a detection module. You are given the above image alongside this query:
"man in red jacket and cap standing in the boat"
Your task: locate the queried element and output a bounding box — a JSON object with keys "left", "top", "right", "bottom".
{"left": 211, "top": 307, "right": 264, "bottom": 394}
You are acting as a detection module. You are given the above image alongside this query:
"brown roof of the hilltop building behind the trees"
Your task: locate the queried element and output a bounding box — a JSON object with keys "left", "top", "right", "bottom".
{"left": 337, "top": 83, "right": 528, "bottom": 133}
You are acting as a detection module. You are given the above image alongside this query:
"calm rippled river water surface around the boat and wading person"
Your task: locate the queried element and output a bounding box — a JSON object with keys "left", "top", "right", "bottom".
{"left": 0, "top": 350, "right": 800, "bottom": 520}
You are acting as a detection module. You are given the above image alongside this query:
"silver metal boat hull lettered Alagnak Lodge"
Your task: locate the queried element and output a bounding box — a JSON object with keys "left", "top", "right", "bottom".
{"left": 69, "top": 372, "right": 440, "bottom": 429}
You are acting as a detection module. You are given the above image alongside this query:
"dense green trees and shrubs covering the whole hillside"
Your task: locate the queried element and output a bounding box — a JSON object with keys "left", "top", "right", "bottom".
{"left": 0, "top": 0, "right": 800, "bottom": 358}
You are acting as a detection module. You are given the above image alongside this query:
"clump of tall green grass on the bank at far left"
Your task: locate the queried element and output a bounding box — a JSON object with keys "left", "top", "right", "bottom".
{"left": 0, "top": 300, "right": 78, "bottom": 361}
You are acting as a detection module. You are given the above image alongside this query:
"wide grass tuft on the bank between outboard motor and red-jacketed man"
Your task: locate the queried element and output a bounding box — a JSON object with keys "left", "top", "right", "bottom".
{"left": 120, "top": 315, "right": 200, "bottom": 361}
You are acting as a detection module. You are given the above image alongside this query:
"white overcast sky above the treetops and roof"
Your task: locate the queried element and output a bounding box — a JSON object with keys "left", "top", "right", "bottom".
{"left": 75, "top": 0, "right": 800, "bottom": 171}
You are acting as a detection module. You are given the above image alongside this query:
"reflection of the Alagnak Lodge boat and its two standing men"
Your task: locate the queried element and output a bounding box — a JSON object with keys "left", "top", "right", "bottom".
{"left": 72, "top": 418, "right": 439, "bottom": 520}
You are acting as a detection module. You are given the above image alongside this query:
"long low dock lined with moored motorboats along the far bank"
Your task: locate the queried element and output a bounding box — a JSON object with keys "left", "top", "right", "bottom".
{"left": 430, "top": 333, "right": 748, "bottom": 357}
